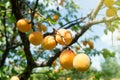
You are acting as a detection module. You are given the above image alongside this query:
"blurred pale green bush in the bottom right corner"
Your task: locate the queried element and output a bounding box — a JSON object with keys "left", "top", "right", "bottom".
{"left": 101, "top": 58, "right": 120, "bottom": 79}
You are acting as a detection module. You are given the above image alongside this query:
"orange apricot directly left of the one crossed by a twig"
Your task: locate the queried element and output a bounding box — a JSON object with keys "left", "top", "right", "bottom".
{"left": 42, "top": 35, "right": 57, "bottom": 50}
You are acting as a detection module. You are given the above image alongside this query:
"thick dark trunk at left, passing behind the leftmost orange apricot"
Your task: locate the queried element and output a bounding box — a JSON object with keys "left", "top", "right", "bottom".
{"left": 10, "top": 0, "right": 35, "bottom": 80}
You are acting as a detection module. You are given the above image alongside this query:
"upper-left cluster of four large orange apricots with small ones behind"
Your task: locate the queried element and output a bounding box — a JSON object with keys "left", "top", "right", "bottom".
{"left": 16, "top": 15, "right": 72, "bottom": 50}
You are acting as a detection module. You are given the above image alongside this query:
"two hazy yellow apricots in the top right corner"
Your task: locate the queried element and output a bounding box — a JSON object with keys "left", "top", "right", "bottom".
{"left": 104, "top": 0, "right": 117, "bottom": 17}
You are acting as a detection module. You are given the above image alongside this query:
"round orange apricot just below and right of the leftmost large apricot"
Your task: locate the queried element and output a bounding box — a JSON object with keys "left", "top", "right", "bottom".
{"left": 29, "top": 31, "right": 43, "bottom": 46}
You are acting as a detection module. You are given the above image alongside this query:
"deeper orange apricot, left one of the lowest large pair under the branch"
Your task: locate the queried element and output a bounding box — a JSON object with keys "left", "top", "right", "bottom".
{"left": 59, "top": 49, "right": 75, "bottom": 69}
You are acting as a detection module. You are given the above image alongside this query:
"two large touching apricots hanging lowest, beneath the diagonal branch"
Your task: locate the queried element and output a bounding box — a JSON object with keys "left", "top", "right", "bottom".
{"left": 59, "top": 49, "right": 90, "bottom": 72}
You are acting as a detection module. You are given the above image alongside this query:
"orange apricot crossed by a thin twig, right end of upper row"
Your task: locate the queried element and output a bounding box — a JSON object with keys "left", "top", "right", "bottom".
{"left": 55, "top": 29, "right": 72, "bottom": 45}
